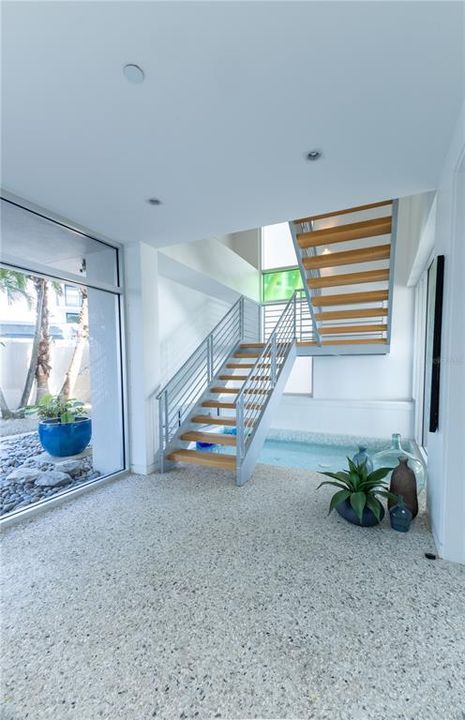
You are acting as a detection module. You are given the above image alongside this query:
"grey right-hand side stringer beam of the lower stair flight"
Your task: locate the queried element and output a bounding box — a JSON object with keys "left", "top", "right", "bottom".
{"left": 236, "top": 341, "right": 297, "bottom": 486}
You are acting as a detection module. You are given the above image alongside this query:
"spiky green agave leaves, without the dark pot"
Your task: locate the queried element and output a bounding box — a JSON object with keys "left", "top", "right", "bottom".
{"left": 318, "top": 458, "right": 397, "bottom": 523}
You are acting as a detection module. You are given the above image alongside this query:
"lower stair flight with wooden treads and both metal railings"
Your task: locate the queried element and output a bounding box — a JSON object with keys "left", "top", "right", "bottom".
{"left": 157, "top": 295, "right": 298, "bottom": 485}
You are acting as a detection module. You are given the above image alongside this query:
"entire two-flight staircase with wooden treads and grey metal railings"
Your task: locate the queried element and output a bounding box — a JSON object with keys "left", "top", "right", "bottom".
{"left": 157, "top": 201, "right": 397, "bottom": 485}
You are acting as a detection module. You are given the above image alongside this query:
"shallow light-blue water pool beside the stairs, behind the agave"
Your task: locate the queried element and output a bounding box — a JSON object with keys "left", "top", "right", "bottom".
{"left": 258, "top": 440, "right": 386, "bottom": 472}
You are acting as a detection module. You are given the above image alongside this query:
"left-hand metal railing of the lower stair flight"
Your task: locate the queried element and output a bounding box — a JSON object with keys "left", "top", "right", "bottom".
{"left": 156, "top": 296, "right": 260, "bottom": 472}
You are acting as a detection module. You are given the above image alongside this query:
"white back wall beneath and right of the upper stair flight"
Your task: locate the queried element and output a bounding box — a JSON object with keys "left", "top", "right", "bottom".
{"left": 273, "top": 198, "right": 423, "bottom": 438}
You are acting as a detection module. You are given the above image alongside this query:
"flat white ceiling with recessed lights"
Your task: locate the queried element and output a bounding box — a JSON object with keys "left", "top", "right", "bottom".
{"left": 2, "top": 2, "right": 463, "bottom": 246}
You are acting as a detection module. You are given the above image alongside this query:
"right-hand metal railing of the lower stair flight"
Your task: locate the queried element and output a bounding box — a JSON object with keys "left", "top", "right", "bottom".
{"left": 236, "top": 292, "right": 297, "bottom": 484}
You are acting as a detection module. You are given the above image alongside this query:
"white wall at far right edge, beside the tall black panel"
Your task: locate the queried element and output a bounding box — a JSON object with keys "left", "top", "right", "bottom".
{"left": 428, "top": 104, "right": 465, "bottom": 563}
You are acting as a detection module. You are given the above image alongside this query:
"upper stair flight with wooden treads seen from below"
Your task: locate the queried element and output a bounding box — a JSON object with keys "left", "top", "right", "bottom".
{"left": 289, "top": 200, "right": 397, "bottom": 355}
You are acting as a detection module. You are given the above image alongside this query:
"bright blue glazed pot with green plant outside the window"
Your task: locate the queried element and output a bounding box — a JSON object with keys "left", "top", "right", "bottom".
{"left": 26, "top": 395, "right": 92, "bottom": 457}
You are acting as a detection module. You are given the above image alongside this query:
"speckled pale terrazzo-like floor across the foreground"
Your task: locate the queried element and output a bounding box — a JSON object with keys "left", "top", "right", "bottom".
{"left": 2, "top": 465, "right": 465, "bottom": 720}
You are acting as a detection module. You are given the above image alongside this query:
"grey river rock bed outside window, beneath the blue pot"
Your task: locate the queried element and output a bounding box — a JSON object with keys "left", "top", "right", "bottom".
{"left": 0, "top": 432, "right": 100, "bottom": 516}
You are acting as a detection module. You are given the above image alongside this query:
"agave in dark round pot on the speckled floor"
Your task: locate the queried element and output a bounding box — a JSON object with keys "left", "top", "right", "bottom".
{"left": 318, "top": 458, "right": 397, "bottom": 527}
